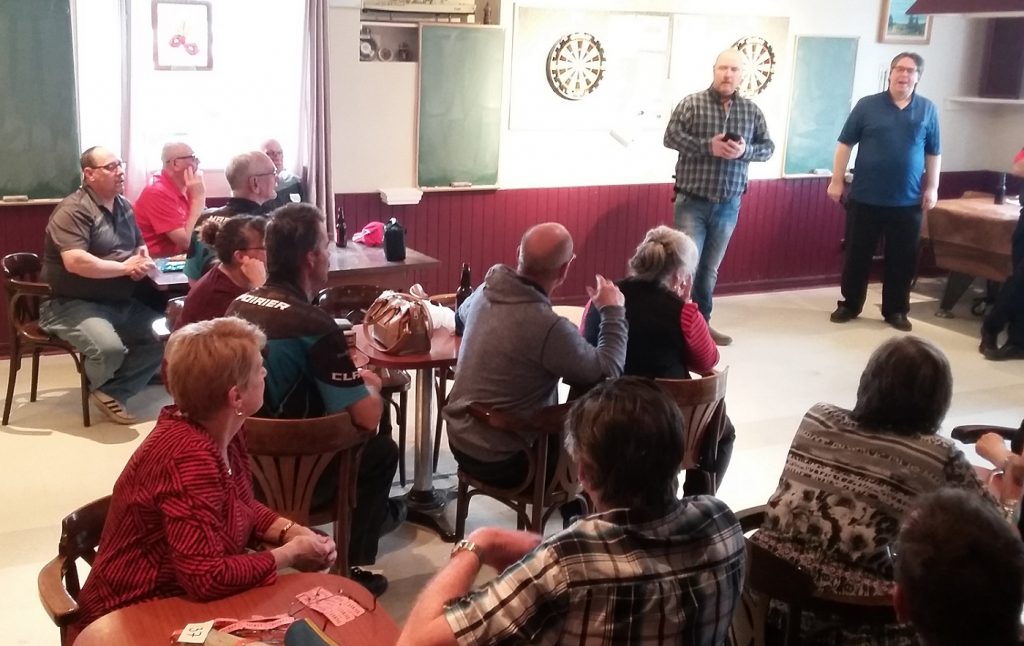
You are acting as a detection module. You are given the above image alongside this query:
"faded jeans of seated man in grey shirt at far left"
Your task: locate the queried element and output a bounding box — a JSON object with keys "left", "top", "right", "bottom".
{"left": 39, "top": 298, "right": 164, "bottom": 402}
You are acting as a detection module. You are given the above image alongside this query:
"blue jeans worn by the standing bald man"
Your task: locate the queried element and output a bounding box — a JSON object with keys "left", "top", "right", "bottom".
{"left": 676, "top": 192, "right": 740, "bottom": 320}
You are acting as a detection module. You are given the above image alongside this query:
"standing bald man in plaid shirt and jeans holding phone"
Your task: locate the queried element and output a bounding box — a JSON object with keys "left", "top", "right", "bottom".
{"left": 665, "top": 49, "right": 775, "bottom": 345}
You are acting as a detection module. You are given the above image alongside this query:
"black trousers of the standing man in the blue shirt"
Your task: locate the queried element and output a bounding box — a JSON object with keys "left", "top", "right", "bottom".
{"left": 839, "top": 200, "right": 922, "bottom": 316}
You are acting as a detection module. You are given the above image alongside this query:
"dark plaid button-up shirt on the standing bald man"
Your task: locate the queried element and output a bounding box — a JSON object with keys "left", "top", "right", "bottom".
{"left": 665, "top": 87, "right": 775, "bottom": 202}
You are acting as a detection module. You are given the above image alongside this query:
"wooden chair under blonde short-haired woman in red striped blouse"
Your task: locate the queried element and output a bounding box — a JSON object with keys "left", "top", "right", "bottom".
{"left": 38, "top": 496, "right": 111, "bottom": 645}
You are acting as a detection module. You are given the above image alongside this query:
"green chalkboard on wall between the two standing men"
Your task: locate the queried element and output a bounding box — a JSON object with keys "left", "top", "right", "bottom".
{"left": 782, "top": 36, "right": 857, "bottom": 175}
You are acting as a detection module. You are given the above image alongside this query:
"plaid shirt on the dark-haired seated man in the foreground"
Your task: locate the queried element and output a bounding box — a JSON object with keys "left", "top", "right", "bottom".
{"left": 445, "top": 496, "right": 744, "bottom": 646}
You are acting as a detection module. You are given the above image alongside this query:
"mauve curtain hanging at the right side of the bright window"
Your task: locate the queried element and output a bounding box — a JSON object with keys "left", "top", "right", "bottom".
{"left": 299, "top": 0, "right": 334, "bottom": 227}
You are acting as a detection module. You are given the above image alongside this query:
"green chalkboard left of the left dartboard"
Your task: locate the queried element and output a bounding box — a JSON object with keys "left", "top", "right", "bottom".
{"left": 417, "top": 25, "right": 505, "bottom": 186}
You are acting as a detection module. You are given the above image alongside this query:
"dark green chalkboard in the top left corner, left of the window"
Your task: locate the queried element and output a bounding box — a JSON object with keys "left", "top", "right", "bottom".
{"left": 0, "top": 0, "right": 80, "bottom": 199}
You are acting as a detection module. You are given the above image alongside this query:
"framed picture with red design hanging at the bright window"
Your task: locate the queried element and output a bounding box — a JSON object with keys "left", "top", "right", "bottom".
{"left": 153, "top": 0, "right": 213, "bottom": 72}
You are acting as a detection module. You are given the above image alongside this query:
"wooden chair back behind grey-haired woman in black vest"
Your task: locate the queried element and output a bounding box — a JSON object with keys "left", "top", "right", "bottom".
{"left": 655, "top": 368, "right": 729, "bottom": 492}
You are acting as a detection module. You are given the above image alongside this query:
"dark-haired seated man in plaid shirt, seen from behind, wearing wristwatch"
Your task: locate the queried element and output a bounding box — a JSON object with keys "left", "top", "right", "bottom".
{"left": 398, "top": 377, "right": 744, "bottom": 646}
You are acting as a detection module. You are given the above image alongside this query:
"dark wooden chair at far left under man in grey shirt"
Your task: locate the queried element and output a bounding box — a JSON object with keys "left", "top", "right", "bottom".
{"left": 2, "top": 253, "right": 89, "bottom": 426}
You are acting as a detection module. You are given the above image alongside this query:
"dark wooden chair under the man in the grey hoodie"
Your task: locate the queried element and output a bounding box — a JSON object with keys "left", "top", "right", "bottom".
{"left": 455, "top": 403, "right": 588, "bottom": 541}
